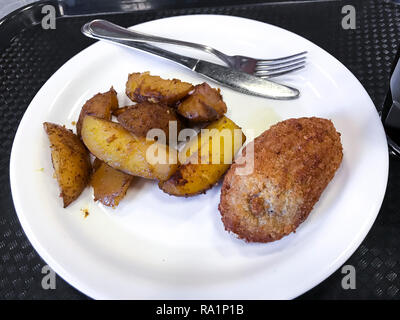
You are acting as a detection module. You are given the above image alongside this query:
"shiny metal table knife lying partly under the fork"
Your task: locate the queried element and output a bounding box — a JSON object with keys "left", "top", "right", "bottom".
{"left": 82, "top": 20, "right": 300, "bottom": 100}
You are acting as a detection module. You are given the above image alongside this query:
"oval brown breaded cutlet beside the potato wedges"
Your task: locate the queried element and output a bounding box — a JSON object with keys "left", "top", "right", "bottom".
{"left": 219, "top": 117, "right": 343, "bottom": 242}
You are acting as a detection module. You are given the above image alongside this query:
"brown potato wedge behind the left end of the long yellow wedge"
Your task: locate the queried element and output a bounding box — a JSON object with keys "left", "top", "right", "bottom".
{"left": 76, "top": 87, "right": 118, "bottom": 137}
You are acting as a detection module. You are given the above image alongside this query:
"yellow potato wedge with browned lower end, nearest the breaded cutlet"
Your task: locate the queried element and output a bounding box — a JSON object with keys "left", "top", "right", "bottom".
{"left": 159, "top": 116, "right": 246, "bottom": 197}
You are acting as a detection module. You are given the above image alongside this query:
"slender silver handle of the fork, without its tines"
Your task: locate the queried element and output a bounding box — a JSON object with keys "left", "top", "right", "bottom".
{"left": 83, "top": 19, "right": 230, "bottom": 65}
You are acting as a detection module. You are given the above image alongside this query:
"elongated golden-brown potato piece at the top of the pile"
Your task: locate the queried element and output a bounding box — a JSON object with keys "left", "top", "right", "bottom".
{"left": 126, "top": 72, "right": 193, "bottom": 104}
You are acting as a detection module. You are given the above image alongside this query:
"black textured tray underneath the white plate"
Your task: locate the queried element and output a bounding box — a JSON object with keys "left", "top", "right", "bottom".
{"left": 0, "top": 0, "right": 400, "bottom": 299}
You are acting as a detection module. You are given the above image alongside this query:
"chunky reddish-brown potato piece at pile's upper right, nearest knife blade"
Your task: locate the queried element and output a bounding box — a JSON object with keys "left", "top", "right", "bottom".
{"left": 178, "top": 82, "right": 227, "bottom": 122}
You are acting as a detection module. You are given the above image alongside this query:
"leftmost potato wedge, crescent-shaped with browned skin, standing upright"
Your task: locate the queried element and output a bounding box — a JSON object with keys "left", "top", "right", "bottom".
{"left": 43, "top": 122, "right": 91, "bottom": 208}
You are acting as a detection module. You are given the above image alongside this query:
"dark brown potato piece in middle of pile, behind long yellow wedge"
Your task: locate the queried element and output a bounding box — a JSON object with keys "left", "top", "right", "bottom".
{"left": 118, "top": 102, "right": 182, "bottom": 143}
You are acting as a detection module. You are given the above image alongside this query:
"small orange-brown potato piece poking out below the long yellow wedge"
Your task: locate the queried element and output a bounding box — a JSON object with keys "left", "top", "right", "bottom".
{"left": 90, "top": 158, "right": 133, "bottom": 207}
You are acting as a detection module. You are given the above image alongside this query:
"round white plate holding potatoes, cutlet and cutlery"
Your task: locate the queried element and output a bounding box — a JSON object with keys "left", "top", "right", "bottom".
{"left": 10, "top": 15, "right": 388, "bottom": 299}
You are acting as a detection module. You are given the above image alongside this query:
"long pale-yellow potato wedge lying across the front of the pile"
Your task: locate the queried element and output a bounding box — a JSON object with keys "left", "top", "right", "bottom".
{"left": 81, "top": 115, "right": 177, "bottom": 180}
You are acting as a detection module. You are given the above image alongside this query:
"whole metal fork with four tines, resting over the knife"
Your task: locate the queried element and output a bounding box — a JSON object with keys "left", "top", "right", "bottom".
{"left": 86, "top": 19, "right": 307, "bottom": 78}
